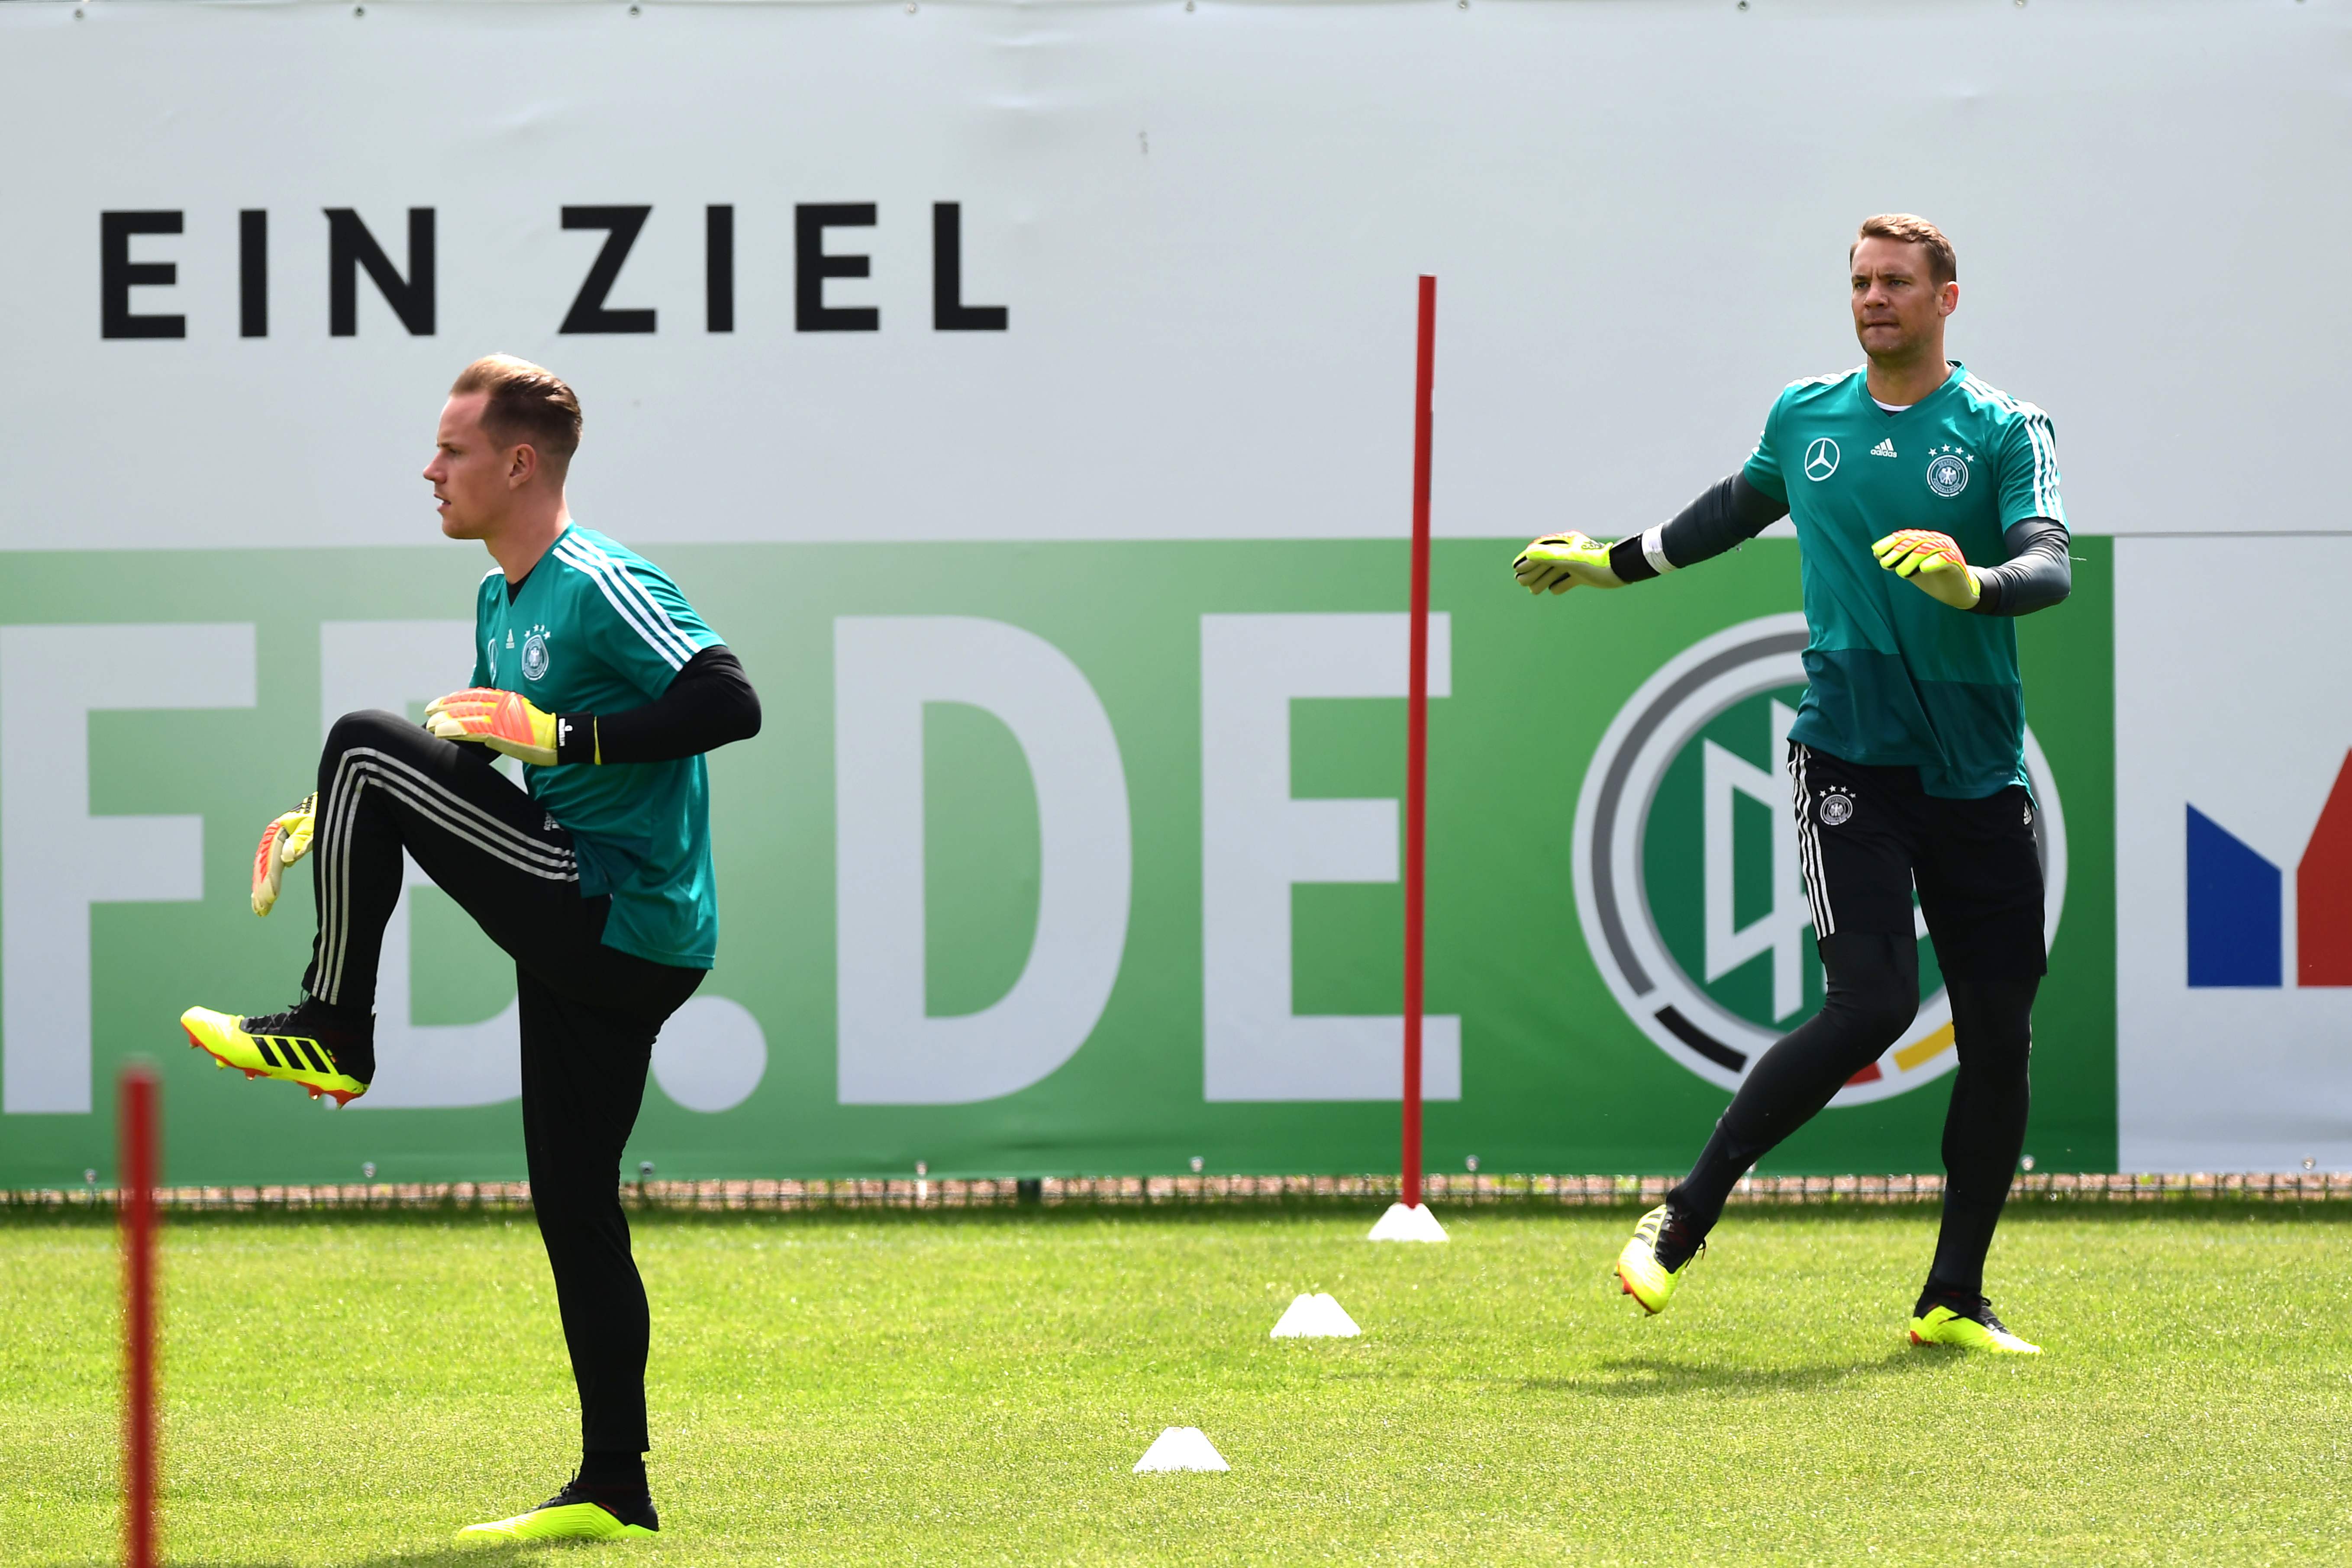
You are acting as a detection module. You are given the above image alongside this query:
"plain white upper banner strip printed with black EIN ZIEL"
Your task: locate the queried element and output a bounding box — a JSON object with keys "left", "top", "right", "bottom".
{"left": 0, "top": 0, "right": 2352, "bottom": 548}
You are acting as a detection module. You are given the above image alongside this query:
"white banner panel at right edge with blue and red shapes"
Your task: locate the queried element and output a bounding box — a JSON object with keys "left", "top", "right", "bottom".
{"left": 2114, "top": 539, "right": 2352, "bottom": 1171}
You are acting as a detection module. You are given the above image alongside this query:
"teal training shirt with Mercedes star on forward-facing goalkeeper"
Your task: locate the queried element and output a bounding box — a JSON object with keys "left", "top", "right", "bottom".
{"left": 1745, "top": 362, "right": 2065, "bottom": 799}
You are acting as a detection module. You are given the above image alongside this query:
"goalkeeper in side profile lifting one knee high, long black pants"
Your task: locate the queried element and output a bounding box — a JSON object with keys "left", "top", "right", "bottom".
{"left": 181, "top": 355, "right": 760, "bottom": 1545}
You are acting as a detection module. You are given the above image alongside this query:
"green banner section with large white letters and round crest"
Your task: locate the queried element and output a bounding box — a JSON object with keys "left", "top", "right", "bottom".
{"left": 0, "top": 543, "right": 2114, "bottom": 1187}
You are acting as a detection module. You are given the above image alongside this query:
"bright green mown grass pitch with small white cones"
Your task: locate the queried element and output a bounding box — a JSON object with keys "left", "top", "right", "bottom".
{"left": 0, "top": 1203, "right": 2352, "bottom": 1568}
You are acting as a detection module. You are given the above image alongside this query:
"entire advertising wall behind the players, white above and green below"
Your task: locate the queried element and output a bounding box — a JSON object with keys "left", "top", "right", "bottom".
{"left": 0, "top": 0, "right": 2352, "bottom": 1185}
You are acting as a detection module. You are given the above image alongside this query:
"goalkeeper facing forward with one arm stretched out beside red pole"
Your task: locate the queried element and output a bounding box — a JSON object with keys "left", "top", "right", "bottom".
{"left": 1515, "top": 214, "right": 2072, "bottom": 1354}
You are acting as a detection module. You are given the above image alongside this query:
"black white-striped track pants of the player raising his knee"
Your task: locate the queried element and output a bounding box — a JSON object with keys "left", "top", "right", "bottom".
{"left": 303, "top": 712, "right": 703, "bottom": 1453}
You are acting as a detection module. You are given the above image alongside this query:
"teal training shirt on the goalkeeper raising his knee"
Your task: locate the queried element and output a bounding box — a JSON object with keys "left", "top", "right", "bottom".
{"left": 473, "top": 524, "right": 724, "bottom": 968}
